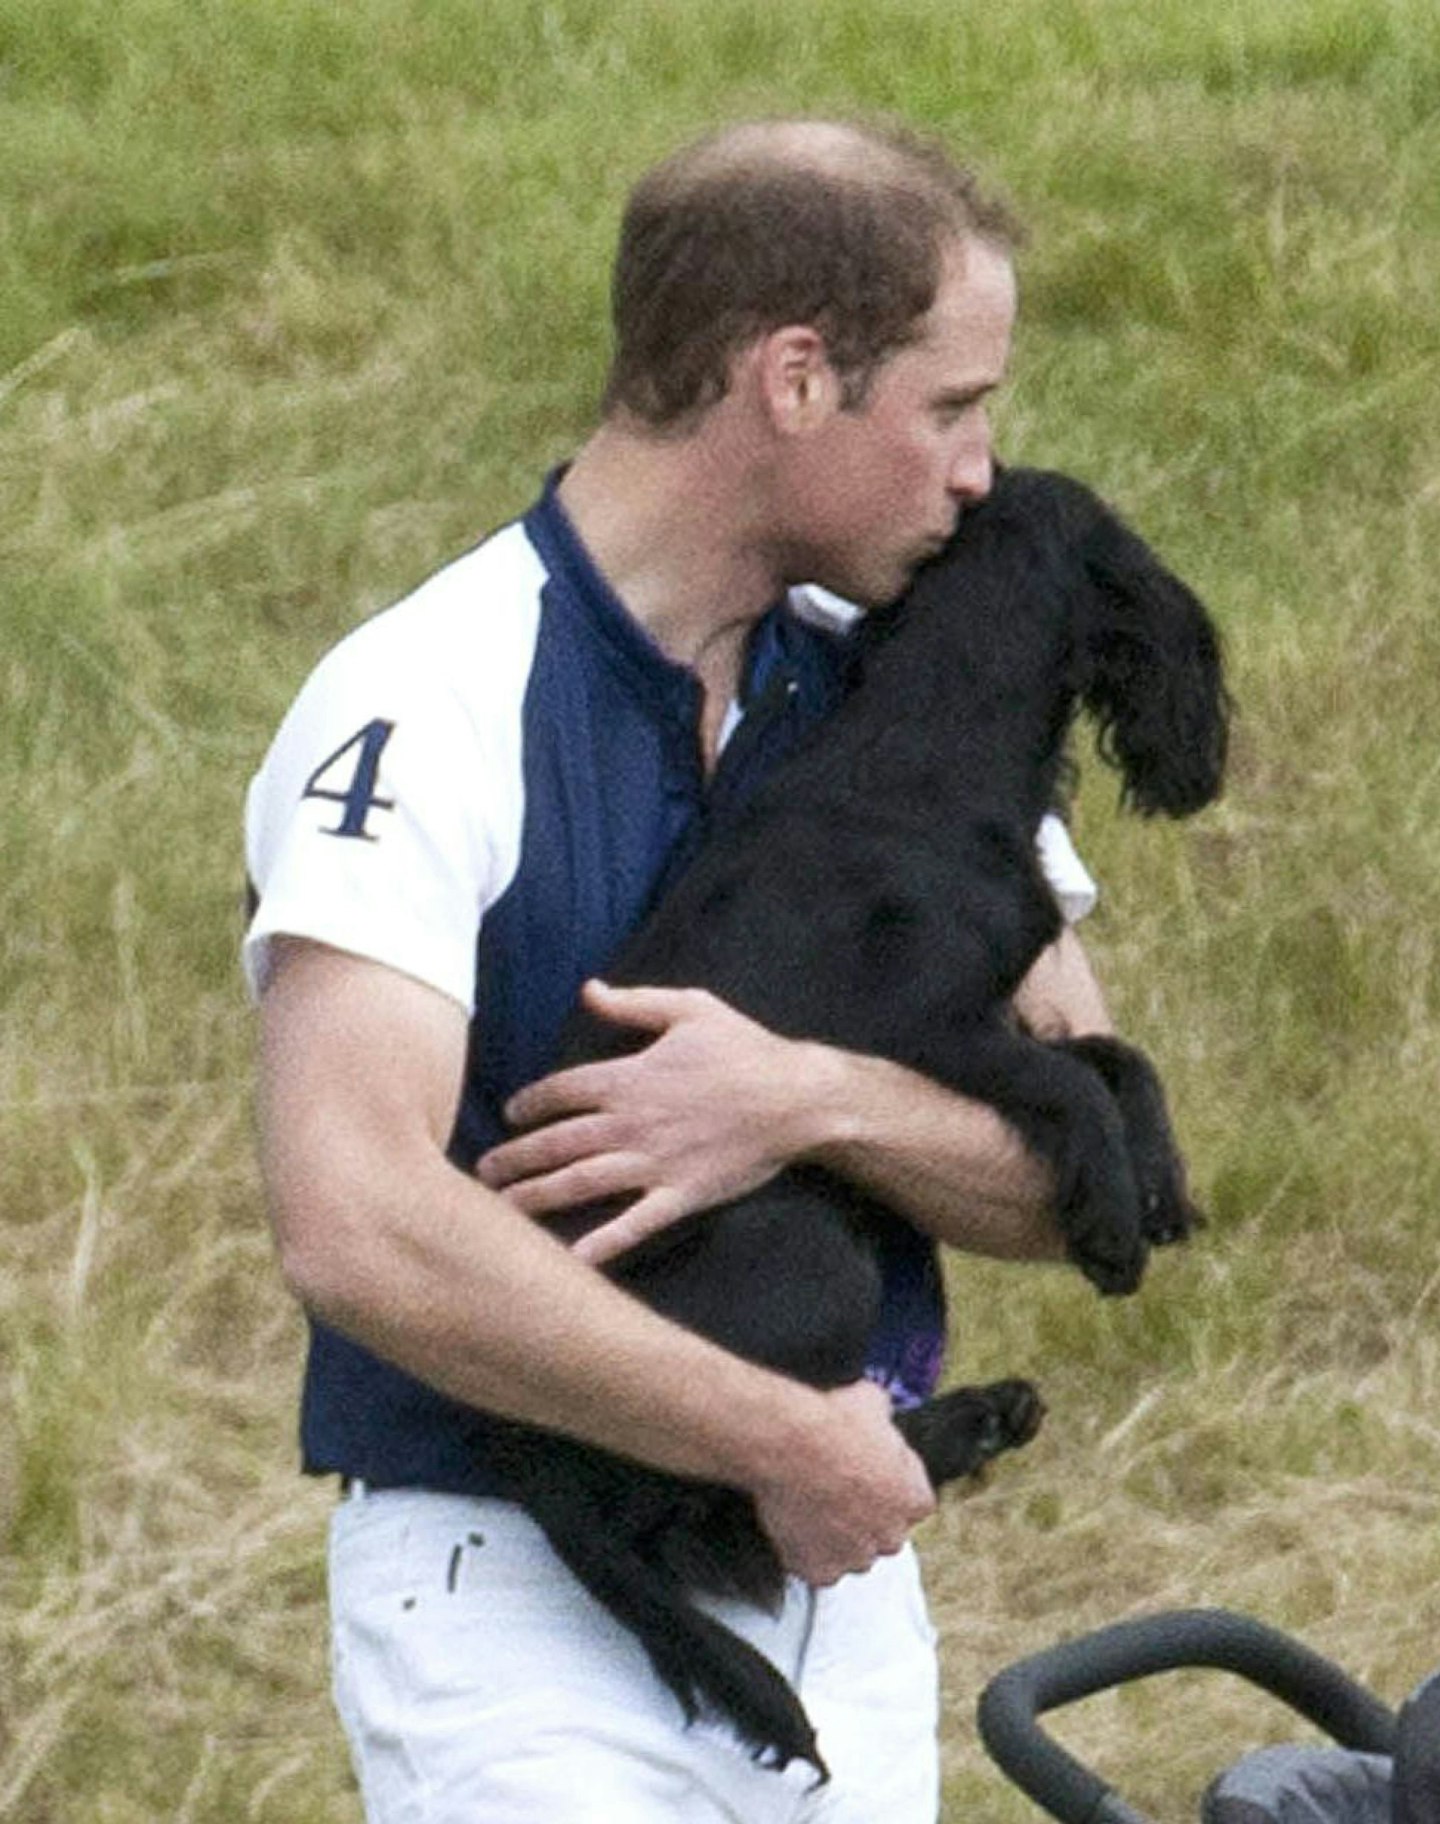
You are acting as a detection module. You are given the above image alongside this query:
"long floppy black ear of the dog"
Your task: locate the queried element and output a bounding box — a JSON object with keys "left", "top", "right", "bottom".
{"left": 1077, "top": 507, "right": 1230, "bottom": 817}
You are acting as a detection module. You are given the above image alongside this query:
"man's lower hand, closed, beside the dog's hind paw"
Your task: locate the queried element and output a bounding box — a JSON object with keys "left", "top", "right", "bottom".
{"left": 752, "top": 1381, "right": 934, "bottom": 1585}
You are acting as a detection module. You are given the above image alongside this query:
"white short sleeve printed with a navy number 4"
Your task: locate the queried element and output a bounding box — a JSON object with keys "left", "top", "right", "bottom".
{"left": 243, "top": 594, "right": 524, "bottom": 1014}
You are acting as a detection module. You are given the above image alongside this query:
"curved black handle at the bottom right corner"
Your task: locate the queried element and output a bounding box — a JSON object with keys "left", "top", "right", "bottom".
{"left": 978, "top": 1609, "right": 1396, "bottom": 1824}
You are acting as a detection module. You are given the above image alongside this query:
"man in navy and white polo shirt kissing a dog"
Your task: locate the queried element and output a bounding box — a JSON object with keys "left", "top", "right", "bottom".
{"left": 246, "top": 120, "right": 1088, "bottom": 1824}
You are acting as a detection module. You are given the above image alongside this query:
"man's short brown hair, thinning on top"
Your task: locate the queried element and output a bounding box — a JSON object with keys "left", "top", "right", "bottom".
{"left": 604, "top": 120, "right": 1024, "bottom": 429}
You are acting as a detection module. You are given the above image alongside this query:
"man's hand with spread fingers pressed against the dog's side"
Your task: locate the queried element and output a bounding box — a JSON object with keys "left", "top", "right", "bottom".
{"left": 476, "top": 981, "right": 823, "bottom": 1264}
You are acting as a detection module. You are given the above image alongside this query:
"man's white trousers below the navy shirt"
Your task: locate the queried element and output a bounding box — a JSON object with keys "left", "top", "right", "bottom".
{"left": 330, "top": 1490, "right": 940, "bottom": 1824}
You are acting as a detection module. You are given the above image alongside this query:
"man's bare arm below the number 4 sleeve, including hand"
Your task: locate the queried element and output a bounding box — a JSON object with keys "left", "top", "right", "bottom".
{"left": 261, "top": 941, "right": 933, "bottom": 1583}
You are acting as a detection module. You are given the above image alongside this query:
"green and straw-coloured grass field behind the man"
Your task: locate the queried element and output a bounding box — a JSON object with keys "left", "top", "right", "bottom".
{"left": 0, "top": 0, "right": 1440, "bottom": 1824}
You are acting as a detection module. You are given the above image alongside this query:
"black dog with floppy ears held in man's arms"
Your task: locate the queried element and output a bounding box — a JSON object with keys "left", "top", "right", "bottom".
{"left": 481, "top": 469, "right": 1228, "bottom": 1773}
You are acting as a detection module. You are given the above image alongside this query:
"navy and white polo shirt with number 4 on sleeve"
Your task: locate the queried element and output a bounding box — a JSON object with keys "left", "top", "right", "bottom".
{"left": 245, "top": 476, "right": 944, "bottom": 1494}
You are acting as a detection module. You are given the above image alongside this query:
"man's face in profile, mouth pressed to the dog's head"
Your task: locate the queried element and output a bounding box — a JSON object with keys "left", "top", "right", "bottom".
{"left": 773, "top": 241, "right": 1015, "bottom": 606}
